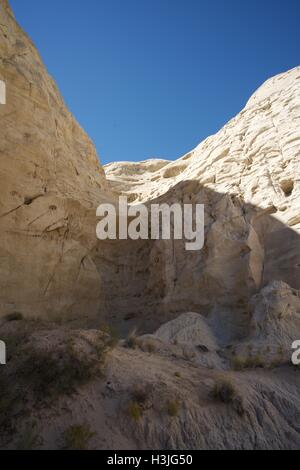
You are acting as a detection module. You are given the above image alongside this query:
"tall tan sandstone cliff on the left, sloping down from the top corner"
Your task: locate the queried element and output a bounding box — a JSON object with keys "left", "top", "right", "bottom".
{"left": 0, "top": 0, "right": 112, "bottom": 319}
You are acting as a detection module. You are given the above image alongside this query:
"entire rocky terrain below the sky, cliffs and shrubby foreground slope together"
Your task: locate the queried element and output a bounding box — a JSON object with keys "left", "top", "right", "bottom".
{"left": 0, "top": 0, "right": 300, "bottom": 449}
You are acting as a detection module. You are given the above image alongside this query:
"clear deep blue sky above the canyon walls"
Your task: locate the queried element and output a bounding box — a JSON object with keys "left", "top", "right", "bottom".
{"left": 10, "top": 0, "right": 300, "bottom": 163}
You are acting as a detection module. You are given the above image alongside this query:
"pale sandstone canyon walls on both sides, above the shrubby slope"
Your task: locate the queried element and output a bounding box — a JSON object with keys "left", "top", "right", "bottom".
{"left": 0, "top": 0, "right": 300, "bottom": 342}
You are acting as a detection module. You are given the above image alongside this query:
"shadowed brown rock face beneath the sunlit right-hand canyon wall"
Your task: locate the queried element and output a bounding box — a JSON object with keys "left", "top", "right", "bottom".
{"left": 93, "top": 181, "right": 300, "bottom": 342}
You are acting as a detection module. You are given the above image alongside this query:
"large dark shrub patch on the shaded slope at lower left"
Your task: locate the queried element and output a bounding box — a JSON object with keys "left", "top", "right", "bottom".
{"left": 0, "top": 330, "right": 113, "bottom": 436}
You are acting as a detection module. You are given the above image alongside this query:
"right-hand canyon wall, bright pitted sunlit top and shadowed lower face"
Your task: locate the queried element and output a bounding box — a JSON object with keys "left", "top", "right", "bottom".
{"left": 105, "top": 68, "right": 300, "bottom": 341}
